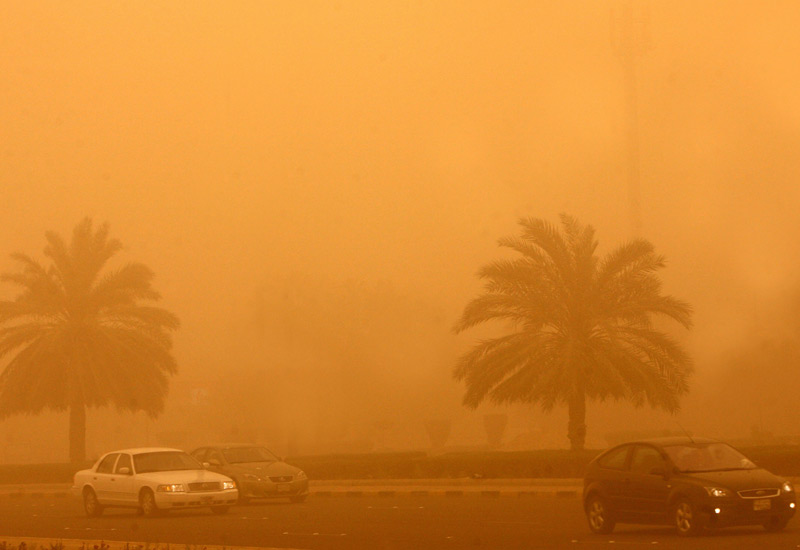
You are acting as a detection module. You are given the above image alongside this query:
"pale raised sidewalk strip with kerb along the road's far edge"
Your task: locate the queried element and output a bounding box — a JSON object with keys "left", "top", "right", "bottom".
{"left": 0, "top": 478, "right": 583, "bottom": 499}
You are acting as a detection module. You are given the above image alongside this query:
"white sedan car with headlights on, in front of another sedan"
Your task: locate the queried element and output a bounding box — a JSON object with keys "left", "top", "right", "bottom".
{"left": 72, "top": 448, "right": 239, "bottom": 516}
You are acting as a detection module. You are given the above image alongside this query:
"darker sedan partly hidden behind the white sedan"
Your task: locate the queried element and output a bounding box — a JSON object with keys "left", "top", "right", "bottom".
{"left": 191, "top": 445, "right": 308, "bottom": 503}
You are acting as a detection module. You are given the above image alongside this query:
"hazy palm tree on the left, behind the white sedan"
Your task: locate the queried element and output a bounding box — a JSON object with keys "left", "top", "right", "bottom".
{"left": 0, "top": 218, "right": 178, "bottom": 462}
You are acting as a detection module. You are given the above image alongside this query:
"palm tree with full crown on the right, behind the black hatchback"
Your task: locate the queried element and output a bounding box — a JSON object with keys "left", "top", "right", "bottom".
{"left": 453, "top": 214, "right": 692, "bottom": 450}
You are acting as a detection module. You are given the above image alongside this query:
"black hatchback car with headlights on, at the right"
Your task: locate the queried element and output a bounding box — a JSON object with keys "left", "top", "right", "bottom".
{"left": 583, "top": 437, "right": 795, "bottom": 536}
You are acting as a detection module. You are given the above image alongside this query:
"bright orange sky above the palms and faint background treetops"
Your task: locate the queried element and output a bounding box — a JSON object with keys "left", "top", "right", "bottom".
{"left": 0, "top": 0, "right": 800, "bottom": 454}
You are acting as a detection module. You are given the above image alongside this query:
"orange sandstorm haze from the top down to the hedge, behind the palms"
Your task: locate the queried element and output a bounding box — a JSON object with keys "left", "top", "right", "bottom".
{"left": 0, "top": 1, "right": 800, "bottom": 462}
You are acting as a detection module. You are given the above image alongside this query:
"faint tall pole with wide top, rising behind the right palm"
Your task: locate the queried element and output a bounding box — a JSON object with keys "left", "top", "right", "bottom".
{"left": 611, "top": 0, "right": 650, "bottom": 237}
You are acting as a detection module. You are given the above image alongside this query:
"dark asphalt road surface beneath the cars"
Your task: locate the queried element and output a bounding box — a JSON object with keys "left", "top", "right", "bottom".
{"left": 0, "top": 496, "right": 800, "bottom": 550}
